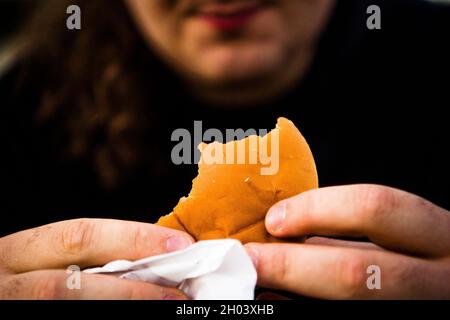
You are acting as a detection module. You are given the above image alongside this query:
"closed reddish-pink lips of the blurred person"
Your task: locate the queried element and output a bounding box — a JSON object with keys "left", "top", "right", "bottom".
{"left": 192, "top": 1, "right": 264, "bottom": 31}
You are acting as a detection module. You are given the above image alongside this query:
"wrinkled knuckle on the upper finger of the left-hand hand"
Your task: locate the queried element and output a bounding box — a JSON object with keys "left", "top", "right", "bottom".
{"left": 60, "top": 219, "right": 95, "bottom": 255}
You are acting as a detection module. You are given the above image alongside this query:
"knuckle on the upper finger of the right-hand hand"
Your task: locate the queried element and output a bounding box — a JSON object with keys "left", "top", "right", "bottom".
{"left": 358, "top": 185, "right": 397, "bottom": 222}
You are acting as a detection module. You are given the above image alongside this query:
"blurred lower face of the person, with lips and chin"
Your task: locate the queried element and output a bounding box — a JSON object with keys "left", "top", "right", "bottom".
{"left": 125, "top": 0, "right": 335, "bottom": 101}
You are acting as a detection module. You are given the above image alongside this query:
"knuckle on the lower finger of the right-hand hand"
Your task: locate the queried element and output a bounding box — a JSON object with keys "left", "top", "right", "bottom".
{"left": 336, "top": 255, "right": 367, "bottom": 299}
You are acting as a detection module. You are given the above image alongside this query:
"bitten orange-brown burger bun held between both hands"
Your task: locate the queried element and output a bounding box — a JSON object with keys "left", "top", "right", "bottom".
{"left": 157, "top": 118, "right": 318, "bottom": 243}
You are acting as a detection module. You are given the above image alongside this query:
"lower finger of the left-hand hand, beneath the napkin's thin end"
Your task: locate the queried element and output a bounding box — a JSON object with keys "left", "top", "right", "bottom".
{"left": 0, "top": 270, "right": 187, "bottom": 300}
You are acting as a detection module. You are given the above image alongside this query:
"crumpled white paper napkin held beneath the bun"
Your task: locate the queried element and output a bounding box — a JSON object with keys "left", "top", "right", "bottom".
{"left": 84, "top": 239, "right": 257, "bottom": 300}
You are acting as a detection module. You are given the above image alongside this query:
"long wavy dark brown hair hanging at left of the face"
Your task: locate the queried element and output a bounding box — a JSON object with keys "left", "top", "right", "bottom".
{"left": 19, "top": 0, "right": 169, "bottom": 188}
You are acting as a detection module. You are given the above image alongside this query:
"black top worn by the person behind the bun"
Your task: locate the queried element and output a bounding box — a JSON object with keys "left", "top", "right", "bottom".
{"left": 0, "top": 0, "right": 450, "bottom": 236}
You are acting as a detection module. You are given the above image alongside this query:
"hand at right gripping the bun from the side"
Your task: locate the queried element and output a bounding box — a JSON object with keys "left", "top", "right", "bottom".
{"left": 247, "top": 185, "right": 450, "bottom": 299}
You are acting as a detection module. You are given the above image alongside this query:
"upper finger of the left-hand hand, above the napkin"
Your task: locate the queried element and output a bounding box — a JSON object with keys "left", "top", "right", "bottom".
{"left": 0, "top": 219, "right": 193, "bottom": 273}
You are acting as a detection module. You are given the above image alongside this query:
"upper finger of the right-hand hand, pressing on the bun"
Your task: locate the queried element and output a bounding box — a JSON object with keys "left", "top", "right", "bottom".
{"left": 266, "top": 185, "right": 450, "bottom": 256}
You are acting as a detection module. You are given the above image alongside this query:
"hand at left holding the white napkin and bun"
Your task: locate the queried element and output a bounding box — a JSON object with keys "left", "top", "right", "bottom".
{"left": 0, "top": 219, "right": 193, "bottom": 300}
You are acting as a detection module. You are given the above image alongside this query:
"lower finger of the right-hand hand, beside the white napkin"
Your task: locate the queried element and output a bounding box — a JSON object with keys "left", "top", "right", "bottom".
{"left": 247, "top": 244, "right": 448, "bottom": 299}
